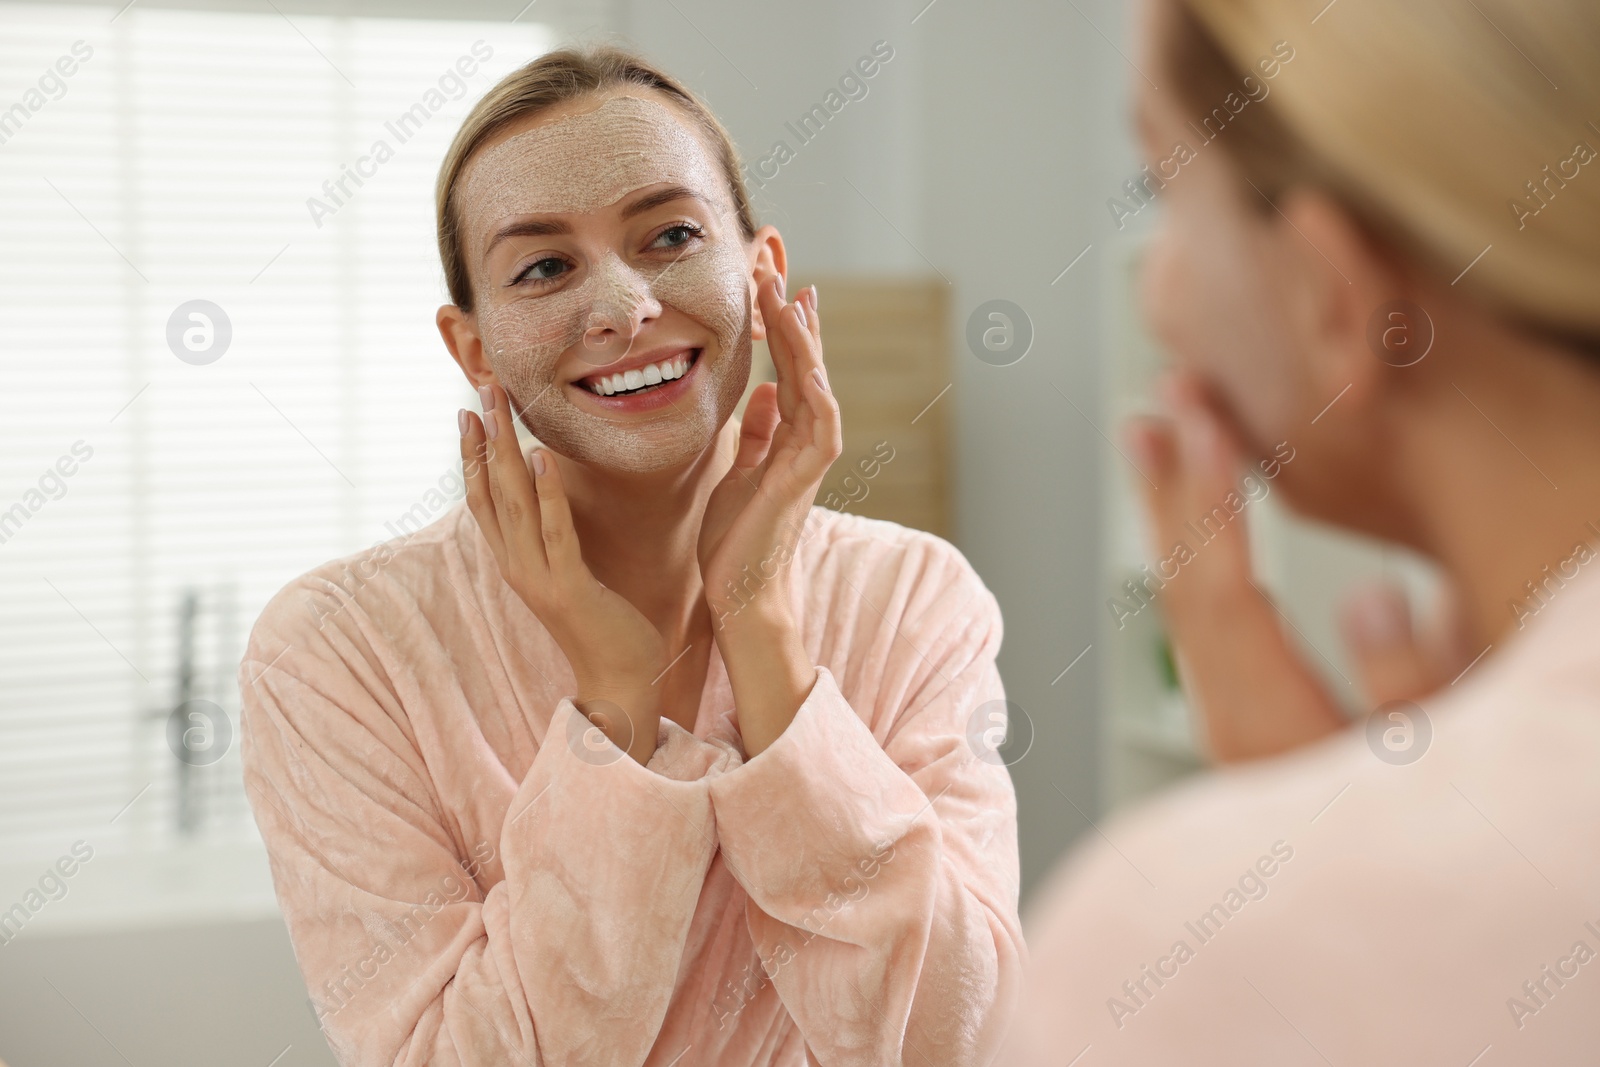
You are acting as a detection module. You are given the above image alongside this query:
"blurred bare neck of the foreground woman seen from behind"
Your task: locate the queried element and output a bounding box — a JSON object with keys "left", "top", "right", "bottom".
{"left": 1402, "top": 336, "right": 1600, "bottom": 646}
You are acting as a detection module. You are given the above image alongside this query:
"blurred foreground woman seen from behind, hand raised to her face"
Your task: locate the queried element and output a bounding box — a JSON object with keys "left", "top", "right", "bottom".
{"left": 1002, "top": 0, "right": 1600, "bottom": 1067}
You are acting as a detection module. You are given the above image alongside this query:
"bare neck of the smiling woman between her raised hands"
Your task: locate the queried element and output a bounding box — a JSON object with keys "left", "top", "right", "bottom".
{"left": 555, "top": 419, "right": 739, "bottom": 648}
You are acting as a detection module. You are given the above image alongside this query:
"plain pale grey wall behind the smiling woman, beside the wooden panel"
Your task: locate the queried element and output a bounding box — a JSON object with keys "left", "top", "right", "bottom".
{"left": 618, "top": 0, "right": 1138, "bottom": 894}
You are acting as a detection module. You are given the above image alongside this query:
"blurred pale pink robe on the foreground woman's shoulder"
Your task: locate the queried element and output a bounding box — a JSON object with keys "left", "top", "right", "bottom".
{"left": 1002, "top": 561, "right": 1600, "bottom": 1067}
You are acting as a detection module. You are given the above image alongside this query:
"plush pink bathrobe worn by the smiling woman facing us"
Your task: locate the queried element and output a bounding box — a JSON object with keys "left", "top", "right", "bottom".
{"left": 240, "top": 504, "right": 1024, "bottom": 1067}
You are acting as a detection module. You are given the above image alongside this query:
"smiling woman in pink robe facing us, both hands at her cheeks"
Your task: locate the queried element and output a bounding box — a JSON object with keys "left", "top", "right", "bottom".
{"left": 240, "top": 50, "right": 1021, "bottom": 1067}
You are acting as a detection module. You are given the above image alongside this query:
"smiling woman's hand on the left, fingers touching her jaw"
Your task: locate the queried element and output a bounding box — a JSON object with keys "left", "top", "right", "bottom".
{"left": 459, "top": 384, "right": 667, "bottom": 763}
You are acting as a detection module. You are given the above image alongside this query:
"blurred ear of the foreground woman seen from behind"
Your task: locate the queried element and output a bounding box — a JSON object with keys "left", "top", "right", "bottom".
{"left": 1275, "top": 189, "right": 1416, "bottom": 422}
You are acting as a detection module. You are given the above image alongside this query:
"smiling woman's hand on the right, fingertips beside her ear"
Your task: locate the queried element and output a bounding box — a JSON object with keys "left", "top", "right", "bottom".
{"left": 699, "top": 278, "right": 843, "bottom": 755}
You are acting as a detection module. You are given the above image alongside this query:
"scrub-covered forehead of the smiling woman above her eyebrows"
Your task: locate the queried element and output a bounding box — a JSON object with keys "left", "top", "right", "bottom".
{"left": 462, "top": 96, "right": 722, "bottom": 227}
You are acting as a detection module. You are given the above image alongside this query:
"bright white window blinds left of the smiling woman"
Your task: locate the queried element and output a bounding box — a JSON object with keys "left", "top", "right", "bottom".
{"left": 0, "top": 0, "right": 552, "bottom": 861}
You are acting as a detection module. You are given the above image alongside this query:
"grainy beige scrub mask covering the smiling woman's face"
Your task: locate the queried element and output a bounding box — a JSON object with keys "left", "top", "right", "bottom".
{"left": 461, "top": 96, "right": 750, "bottom": 472}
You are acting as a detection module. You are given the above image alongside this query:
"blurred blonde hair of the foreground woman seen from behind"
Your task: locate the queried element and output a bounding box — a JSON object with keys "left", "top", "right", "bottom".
{"left": 1168, "top": 0, "right": 1600, "bottom": 347}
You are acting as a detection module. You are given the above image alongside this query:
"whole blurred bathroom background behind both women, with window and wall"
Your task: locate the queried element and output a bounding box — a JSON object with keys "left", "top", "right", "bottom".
{"left": 0, "top": 0, "right": 1426, "bottom": 1067}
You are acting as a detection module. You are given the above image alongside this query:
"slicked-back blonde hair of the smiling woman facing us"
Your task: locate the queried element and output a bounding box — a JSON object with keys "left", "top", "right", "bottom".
{"left": 434, "top": 45, "right": 755, "bottom": 312}
